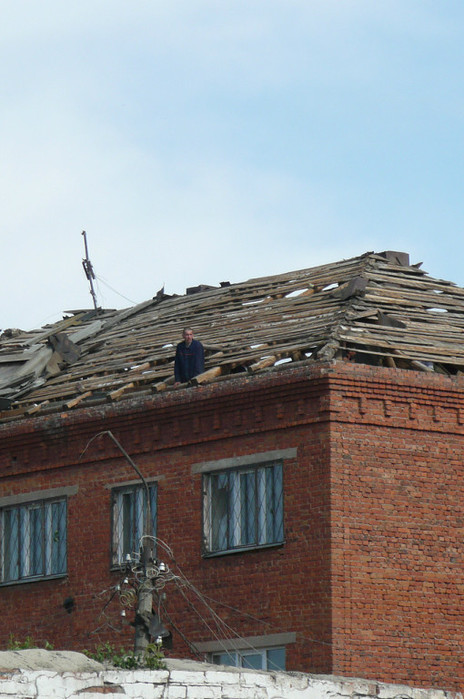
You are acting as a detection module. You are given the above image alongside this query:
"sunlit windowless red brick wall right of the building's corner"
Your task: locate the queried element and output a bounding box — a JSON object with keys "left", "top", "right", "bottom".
{"left": 331, "top": 365, "right": 464, "bottom": 689}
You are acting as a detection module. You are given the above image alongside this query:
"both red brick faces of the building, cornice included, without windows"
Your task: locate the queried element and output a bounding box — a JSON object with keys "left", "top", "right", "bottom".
{"left": 0, "top": 363, "right": 464, "bottom": 689}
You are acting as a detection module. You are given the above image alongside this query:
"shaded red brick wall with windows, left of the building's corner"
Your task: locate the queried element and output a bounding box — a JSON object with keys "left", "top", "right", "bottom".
{"left": 0, "top": 372, "right": 331, "bottom": 672}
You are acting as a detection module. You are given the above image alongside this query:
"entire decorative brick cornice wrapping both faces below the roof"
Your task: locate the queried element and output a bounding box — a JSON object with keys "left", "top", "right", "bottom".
{"left": 0, "top": 361, "right": 464, "bottom": 474}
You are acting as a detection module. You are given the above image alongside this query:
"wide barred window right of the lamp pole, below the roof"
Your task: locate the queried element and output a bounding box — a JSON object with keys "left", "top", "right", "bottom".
{"left": 204, "top": 461, "right": 284, "bottom": 554}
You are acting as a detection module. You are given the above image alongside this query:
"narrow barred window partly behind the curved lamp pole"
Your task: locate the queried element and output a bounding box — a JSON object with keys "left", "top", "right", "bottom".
{"left": 112, "top": 484, "right": 156, "bottom": 566}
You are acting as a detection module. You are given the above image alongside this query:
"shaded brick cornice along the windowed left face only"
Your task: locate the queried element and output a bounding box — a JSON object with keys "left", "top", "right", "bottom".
{"left": 0, "top": 365, "right": 329, "bottom": 475}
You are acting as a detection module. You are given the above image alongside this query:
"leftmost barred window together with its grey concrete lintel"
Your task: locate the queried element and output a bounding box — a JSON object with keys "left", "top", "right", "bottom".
{"left": 0, "top": 488, "right": 67, "bottom": 587}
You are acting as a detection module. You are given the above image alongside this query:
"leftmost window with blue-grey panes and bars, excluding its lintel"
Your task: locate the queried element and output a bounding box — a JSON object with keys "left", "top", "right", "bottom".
{"left": 0, "top": 499, "right": 66, "bottom": 583}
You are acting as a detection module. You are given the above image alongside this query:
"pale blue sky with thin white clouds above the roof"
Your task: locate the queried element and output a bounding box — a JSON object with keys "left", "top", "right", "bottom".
{"left": 0, "top": 0, "right": 464, "bottom": 329}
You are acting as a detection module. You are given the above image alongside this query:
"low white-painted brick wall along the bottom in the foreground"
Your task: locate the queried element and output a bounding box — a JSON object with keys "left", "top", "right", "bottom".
{"left": 0, "top": 664, "right": 462, "bottom": 699}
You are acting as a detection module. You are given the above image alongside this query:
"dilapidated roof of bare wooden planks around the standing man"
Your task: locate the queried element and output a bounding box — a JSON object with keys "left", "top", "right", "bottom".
{"left": 0, "top": 251, "right": 464, "bottom": 421}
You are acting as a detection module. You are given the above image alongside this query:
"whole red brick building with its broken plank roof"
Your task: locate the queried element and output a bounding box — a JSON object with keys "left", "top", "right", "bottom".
{"left": 0, "top": 252, "right": 464, "bottom": 690}
